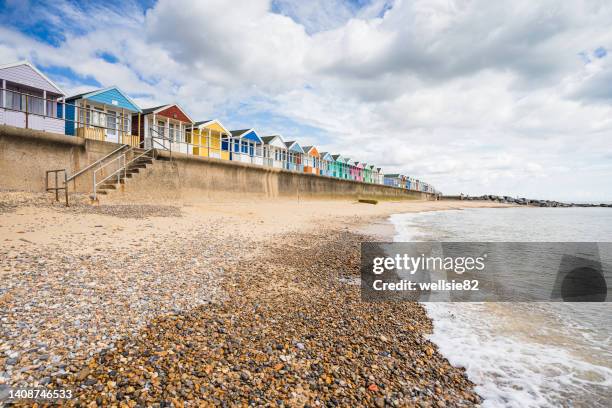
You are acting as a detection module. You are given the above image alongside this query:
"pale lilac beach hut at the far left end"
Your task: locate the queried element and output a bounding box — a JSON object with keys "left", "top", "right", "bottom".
{"left": 0, "top": 61, "right": 65, "bottom": 134}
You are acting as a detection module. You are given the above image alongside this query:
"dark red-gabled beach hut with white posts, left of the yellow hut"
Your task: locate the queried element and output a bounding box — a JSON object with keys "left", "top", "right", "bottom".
{"left": 132, "top": 104, "right": 193, "bottom": 154}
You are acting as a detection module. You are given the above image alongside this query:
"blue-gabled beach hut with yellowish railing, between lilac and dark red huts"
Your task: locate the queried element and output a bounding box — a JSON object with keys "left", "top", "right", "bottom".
{"left": 65, "top": 86, "right": 142, "bottom": 146}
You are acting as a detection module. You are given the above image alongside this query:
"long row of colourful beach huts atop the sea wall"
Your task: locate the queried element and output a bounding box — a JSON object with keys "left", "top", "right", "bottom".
{"left": 0, "top": 61, "right": 437, "bottom": 193}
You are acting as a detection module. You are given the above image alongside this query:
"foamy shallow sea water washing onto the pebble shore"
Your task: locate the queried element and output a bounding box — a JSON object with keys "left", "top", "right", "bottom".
{"left": 391, "top": 207, "right": 612, "bottom": 407}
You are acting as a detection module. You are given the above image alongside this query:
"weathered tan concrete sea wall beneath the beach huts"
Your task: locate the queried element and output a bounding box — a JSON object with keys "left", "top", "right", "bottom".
{"left": 0, "top": 126, "right": 432, "bottom": 200}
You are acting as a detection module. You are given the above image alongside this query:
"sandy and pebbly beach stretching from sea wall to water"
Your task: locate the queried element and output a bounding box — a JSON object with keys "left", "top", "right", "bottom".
{"left": 0, "top": 192, "right": 510, "bottom": 406}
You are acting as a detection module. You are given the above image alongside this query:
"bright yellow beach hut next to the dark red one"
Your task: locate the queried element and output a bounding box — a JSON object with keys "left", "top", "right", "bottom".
{"left": 188, "top": 119, "right": 231, "bottom": 160}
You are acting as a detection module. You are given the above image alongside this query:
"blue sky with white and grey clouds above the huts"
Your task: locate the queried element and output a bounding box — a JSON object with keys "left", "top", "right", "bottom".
{"left": 0, "top": 0, "right": 612, "bottom": 201}
